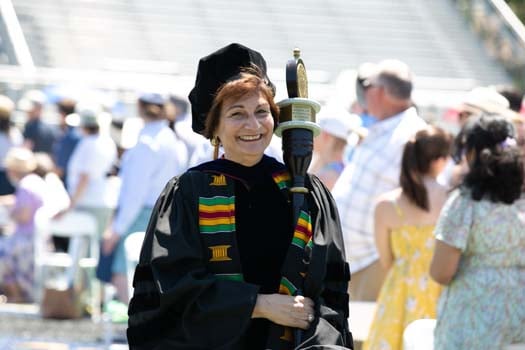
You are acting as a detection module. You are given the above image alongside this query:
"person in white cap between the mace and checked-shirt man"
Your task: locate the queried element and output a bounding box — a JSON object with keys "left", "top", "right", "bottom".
{"left": 309, "top": 107, "right": 361, "bottom": 190}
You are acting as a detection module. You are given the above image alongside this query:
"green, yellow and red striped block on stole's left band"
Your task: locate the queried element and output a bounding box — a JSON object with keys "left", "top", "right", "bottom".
{"left": 199, "top": 196, "right": 235, "bottom": 234}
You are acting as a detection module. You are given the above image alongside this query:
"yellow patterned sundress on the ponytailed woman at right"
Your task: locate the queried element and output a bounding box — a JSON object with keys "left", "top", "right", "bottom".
{"left": 363, "top": 207, "right": 441, "bottom": 350}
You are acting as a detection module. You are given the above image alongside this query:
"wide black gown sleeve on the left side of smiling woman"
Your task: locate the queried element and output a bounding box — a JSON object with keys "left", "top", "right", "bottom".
{"left": 127, "top": 171, "right": 258, "bottom": 349}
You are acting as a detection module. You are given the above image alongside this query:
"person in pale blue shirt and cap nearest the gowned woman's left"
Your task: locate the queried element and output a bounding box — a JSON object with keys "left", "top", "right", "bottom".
{"left": 99, "top": 93, "right": 188, "bottom": 303}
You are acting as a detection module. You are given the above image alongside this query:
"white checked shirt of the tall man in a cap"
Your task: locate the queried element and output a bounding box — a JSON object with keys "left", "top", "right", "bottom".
{"left": 332, "top": 107, "right": 426, "bottom": 272}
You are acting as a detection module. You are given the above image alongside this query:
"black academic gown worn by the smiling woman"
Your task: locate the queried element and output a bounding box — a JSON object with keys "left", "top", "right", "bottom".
{"left": 127, "top": 156, "right": 353, "bottom": 350}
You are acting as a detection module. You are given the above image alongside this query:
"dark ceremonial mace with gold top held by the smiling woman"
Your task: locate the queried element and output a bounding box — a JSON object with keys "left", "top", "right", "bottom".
{"left": 275, "top": 48, "right": 321, "bottom": 346}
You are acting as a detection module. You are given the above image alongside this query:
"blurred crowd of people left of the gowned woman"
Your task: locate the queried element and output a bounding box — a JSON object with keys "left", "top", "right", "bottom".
{"left": 0, "top": 90, "right": 204, "bottom": 303}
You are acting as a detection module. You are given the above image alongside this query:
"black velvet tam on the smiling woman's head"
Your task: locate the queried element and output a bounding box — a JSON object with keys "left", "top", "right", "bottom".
{"left": 188, "top": 44, "right": 275, "bottom": 134}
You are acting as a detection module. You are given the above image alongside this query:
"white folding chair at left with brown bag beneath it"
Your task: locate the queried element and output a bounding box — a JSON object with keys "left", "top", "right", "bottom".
{"left": 35, "top": 211, "right": 100, "bottom": 319}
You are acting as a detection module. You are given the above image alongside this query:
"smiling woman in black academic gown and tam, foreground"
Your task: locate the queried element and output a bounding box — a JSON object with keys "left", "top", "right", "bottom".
{"left": 127, "top": 44, "right": 353, "bottom": 350}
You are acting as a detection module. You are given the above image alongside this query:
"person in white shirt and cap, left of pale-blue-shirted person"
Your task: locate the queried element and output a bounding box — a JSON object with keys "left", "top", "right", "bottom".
{"left": 59, "top": 108, "right": 117, "bottom": 242}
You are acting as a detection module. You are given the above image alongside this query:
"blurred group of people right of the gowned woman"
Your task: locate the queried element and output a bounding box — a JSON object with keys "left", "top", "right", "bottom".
{"left": 320, "top": 60, "right": 525, "bottom": 349}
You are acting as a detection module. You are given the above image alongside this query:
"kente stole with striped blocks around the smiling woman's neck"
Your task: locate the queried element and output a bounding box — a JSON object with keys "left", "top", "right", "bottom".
{"left": 195, "top": 162, "right": 313, "bottom": 350}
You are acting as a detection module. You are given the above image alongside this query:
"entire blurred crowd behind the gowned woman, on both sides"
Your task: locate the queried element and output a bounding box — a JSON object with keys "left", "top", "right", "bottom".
{"left": 0, "top": 56, "right": 525, "bottom": 349}
